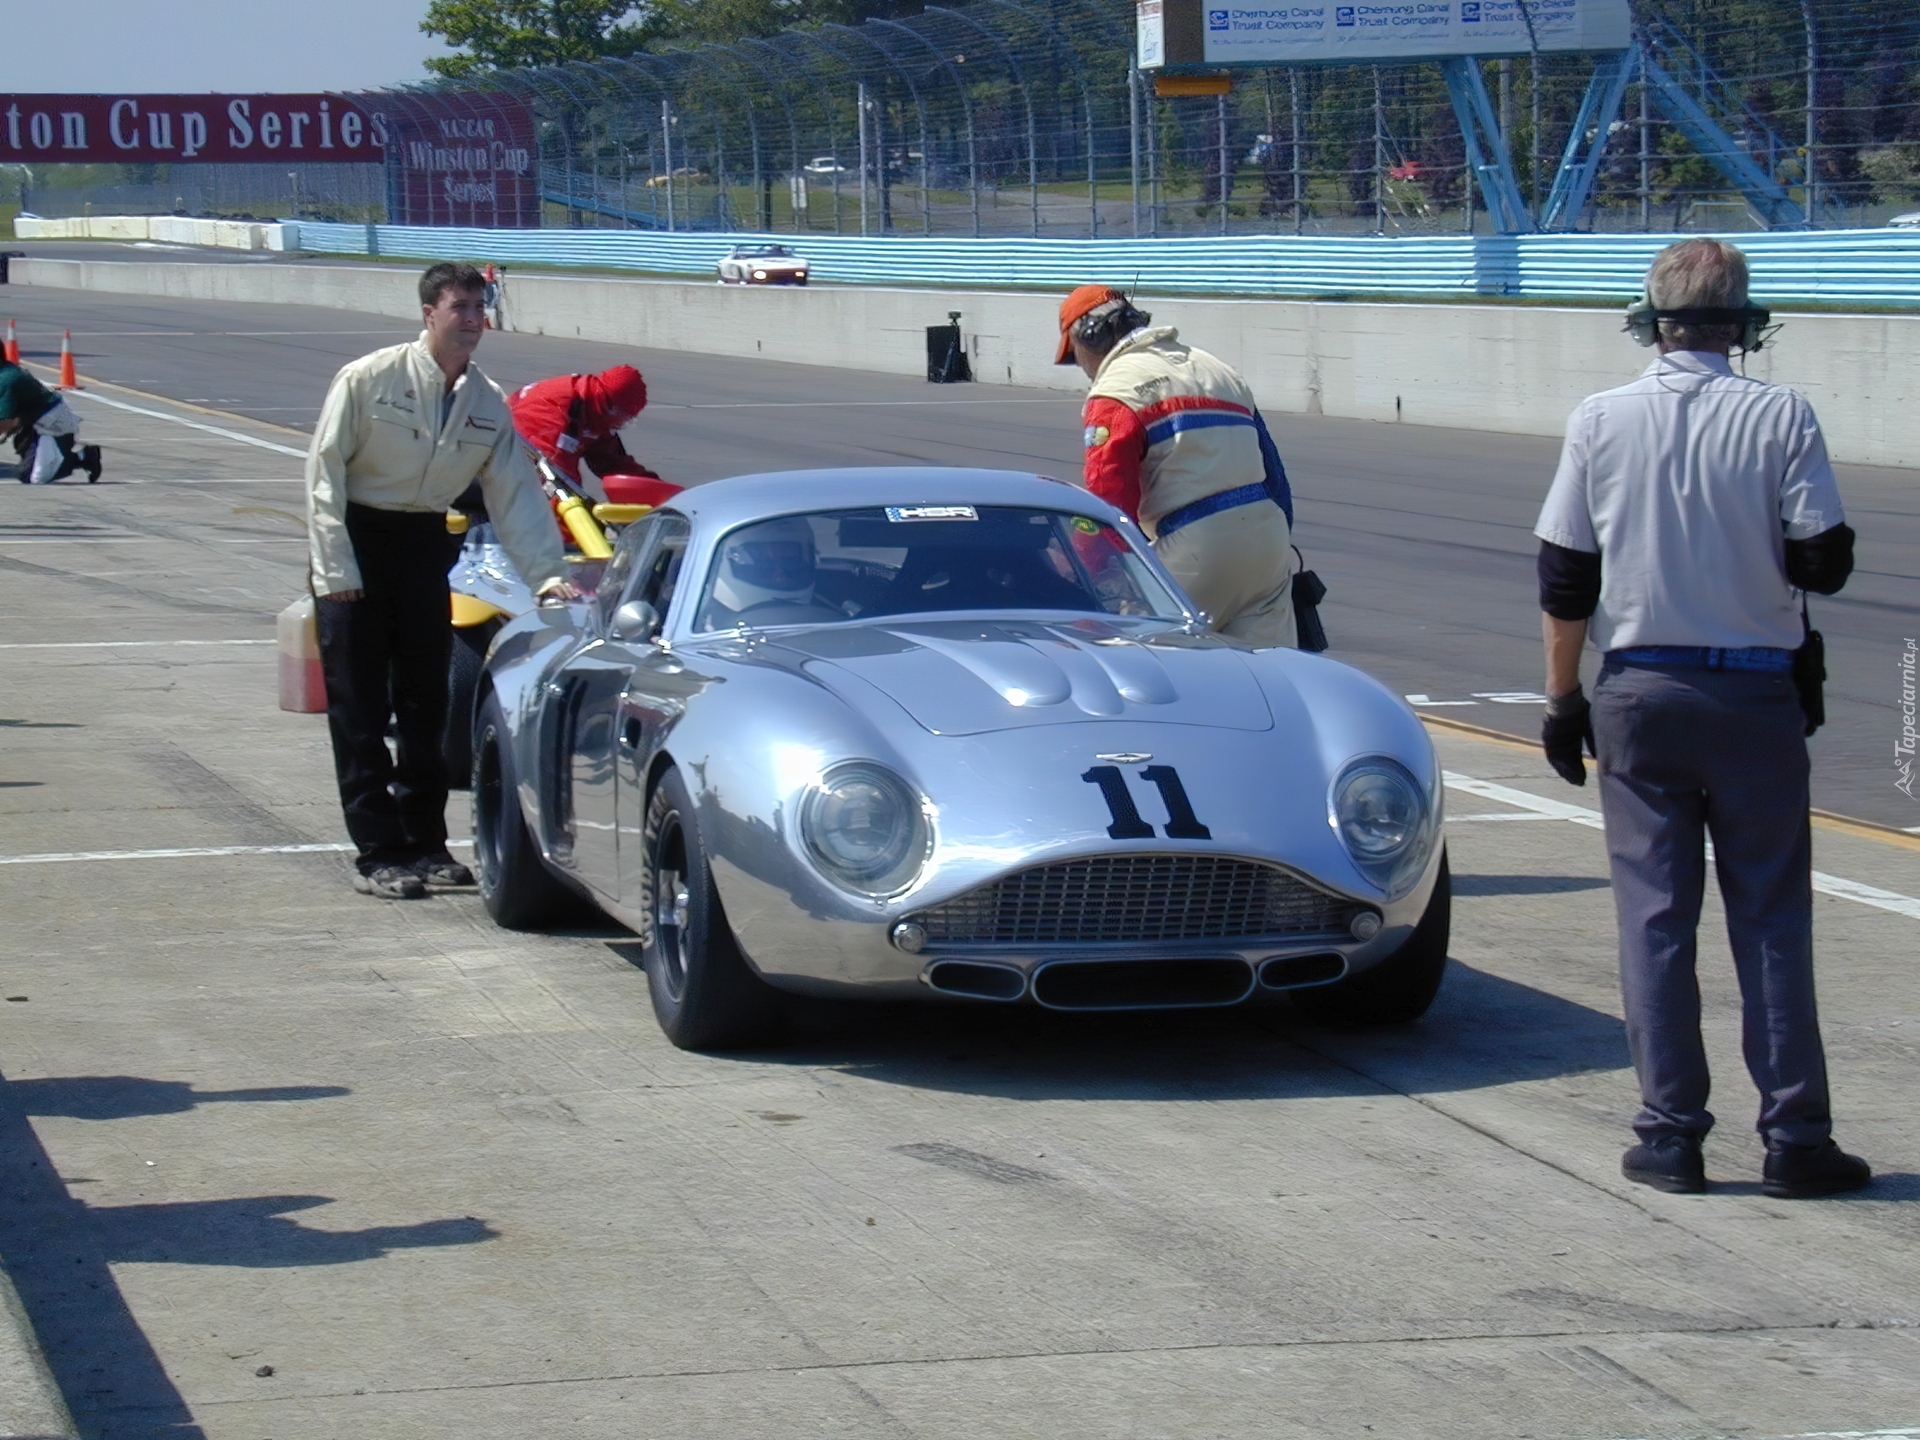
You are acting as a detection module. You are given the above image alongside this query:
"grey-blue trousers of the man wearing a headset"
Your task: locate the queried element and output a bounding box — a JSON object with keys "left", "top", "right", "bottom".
{"left": 1594, "top": 659, "right": 1832, "bottom": 1144}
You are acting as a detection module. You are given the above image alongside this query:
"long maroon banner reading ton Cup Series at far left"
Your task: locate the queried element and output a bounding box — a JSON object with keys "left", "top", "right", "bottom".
{"left": 0, "top": 94, "right": 386, "bottom": 165}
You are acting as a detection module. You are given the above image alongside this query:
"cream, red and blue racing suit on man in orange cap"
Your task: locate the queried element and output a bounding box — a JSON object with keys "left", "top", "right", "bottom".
{"left": 1083, "top": 326, "right": 1298, "bottom": 647}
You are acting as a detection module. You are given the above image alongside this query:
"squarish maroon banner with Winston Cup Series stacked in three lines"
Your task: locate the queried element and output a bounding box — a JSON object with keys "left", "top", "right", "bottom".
{"left": 361, "top": 90, "right": 540, "bottom": 230}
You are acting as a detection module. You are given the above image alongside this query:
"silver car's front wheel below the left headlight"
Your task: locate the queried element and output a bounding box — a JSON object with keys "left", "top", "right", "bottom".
{"left": 641, "top": 770, "right": 781, "bottom": 1050}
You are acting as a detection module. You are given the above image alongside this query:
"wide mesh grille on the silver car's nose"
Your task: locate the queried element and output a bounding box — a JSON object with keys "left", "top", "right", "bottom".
{"left": 908, "top": 854, "right": 1354, "bottom": 945}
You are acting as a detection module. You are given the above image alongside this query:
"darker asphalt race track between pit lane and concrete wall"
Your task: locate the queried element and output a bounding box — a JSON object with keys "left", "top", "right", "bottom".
{"left": 0, "top": 268, "right": 1920, "bottom": 829}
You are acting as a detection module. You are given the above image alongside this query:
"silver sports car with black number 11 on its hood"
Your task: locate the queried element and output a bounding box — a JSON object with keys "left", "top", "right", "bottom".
{"left": 472, "top": 468, "right": 1450, "bottom": 1046}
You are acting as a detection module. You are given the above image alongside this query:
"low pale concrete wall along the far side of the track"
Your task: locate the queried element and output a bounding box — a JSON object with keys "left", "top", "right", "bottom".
{"left": 12, "top": 259, "right": 1920, "bottom": 468}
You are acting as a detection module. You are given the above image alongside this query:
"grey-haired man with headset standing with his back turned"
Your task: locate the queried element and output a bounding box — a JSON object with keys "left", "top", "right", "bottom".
{"left": 1534, "top": 240, "right": 1872, "bottom": 1198}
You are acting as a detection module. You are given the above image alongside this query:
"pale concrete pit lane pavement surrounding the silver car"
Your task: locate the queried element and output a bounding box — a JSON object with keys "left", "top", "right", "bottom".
{"left": 0, "top": 380, "right": 1920, "bottom": 1440}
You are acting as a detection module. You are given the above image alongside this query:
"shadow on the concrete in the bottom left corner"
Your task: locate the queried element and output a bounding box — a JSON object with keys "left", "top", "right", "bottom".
{"left": 0, "top": 1075, "right": 495, "bottom": 1440}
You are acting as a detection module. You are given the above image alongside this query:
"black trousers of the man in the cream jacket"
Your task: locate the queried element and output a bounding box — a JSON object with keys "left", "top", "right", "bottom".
{"left": 317, "top": 505, "right": 453, "bottom": 872}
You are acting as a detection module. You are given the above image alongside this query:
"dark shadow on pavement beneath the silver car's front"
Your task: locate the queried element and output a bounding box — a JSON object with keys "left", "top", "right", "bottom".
{"left": 755, "top": 960, "right": 1628, "bottom": 1100}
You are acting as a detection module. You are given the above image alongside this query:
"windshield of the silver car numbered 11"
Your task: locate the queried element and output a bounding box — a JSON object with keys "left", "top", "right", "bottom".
{"left": 693, "top": 505, "right": 1183, "bottom": 630}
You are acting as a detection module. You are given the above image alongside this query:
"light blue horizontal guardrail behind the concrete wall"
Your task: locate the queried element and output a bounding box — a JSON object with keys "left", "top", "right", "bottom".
{"left": 300, "top": 223, "right": 1920, "bottom": 307}
